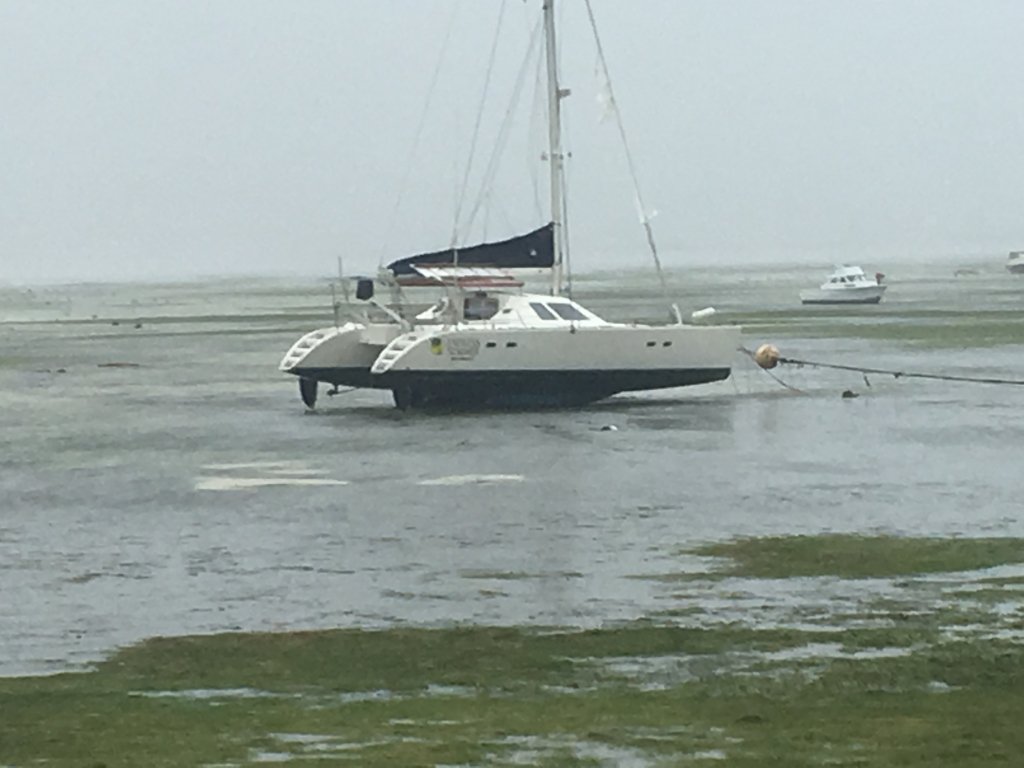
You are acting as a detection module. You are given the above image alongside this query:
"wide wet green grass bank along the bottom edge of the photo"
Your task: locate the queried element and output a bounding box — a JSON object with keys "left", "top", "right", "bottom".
{"left": 0, "top": 624, "right": 1024, "bottom": 768}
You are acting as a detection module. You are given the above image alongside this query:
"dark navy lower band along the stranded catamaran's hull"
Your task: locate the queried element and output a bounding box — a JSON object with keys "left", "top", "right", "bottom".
{"left": 291, "top": 368, "right": 730, "bottom": 408}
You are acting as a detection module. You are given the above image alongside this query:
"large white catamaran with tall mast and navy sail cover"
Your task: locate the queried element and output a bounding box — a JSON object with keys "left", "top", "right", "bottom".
{"left": 280, "top": 0, "right": 740, "bottom": 410}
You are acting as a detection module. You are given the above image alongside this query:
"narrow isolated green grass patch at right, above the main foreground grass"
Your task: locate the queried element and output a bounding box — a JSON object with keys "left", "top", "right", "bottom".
{"left": 686, "top": 534, "right": 1024, "bottom": 579}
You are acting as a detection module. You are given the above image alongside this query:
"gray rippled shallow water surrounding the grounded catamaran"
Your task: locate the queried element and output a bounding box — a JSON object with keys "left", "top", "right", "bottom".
{"left": 0, "top": 262, "right": 1024, "bottom": 675}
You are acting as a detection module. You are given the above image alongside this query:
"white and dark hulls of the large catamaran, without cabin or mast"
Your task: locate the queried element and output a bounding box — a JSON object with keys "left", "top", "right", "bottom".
{"left": 281, "top": 313, "right": 739, "bottom": 409}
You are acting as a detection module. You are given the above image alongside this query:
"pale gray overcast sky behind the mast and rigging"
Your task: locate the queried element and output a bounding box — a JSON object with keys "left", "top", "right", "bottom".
{"left": 0, "top": 0, "right": 1024, "bottom": 283}
